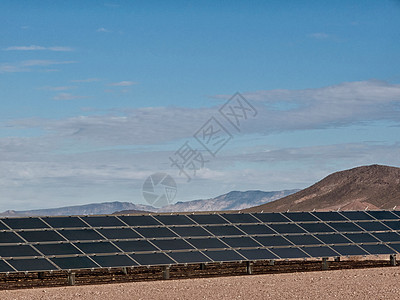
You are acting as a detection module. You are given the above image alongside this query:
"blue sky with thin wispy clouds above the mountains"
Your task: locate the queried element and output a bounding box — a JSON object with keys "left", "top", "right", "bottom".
{"left": 0, "top": 0, "right": 400, "bottom": 210}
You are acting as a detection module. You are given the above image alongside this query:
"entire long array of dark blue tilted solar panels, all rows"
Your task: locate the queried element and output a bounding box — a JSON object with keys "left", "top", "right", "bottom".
{"left": 0, "top": 211, "right": 400, "bottom": 273}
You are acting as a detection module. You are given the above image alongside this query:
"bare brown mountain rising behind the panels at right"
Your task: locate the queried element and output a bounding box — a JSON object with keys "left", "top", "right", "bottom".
{"left": 243, "top": 165, "right": 400, "bottom": 212}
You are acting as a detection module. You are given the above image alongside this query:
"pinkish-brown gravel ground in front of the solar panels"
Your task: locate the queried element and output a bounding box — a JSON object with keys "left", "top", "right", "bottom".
{"left": 0, "top": 267, "right": 400, "bottom": 300}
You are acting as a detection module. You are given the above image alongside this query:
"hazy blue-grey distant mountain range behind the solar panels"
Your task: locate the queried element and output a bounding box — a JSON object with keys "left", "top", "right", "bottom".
{"left": 0, "top": 190, "right": 298, "bottom": 217}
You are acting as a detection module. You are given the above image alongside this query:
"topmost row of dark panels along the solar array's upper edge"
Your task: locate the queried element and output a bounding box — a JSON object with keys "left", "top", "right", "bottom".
{"left": 0, "top": 211, "right": 400, "bottom": 230}
